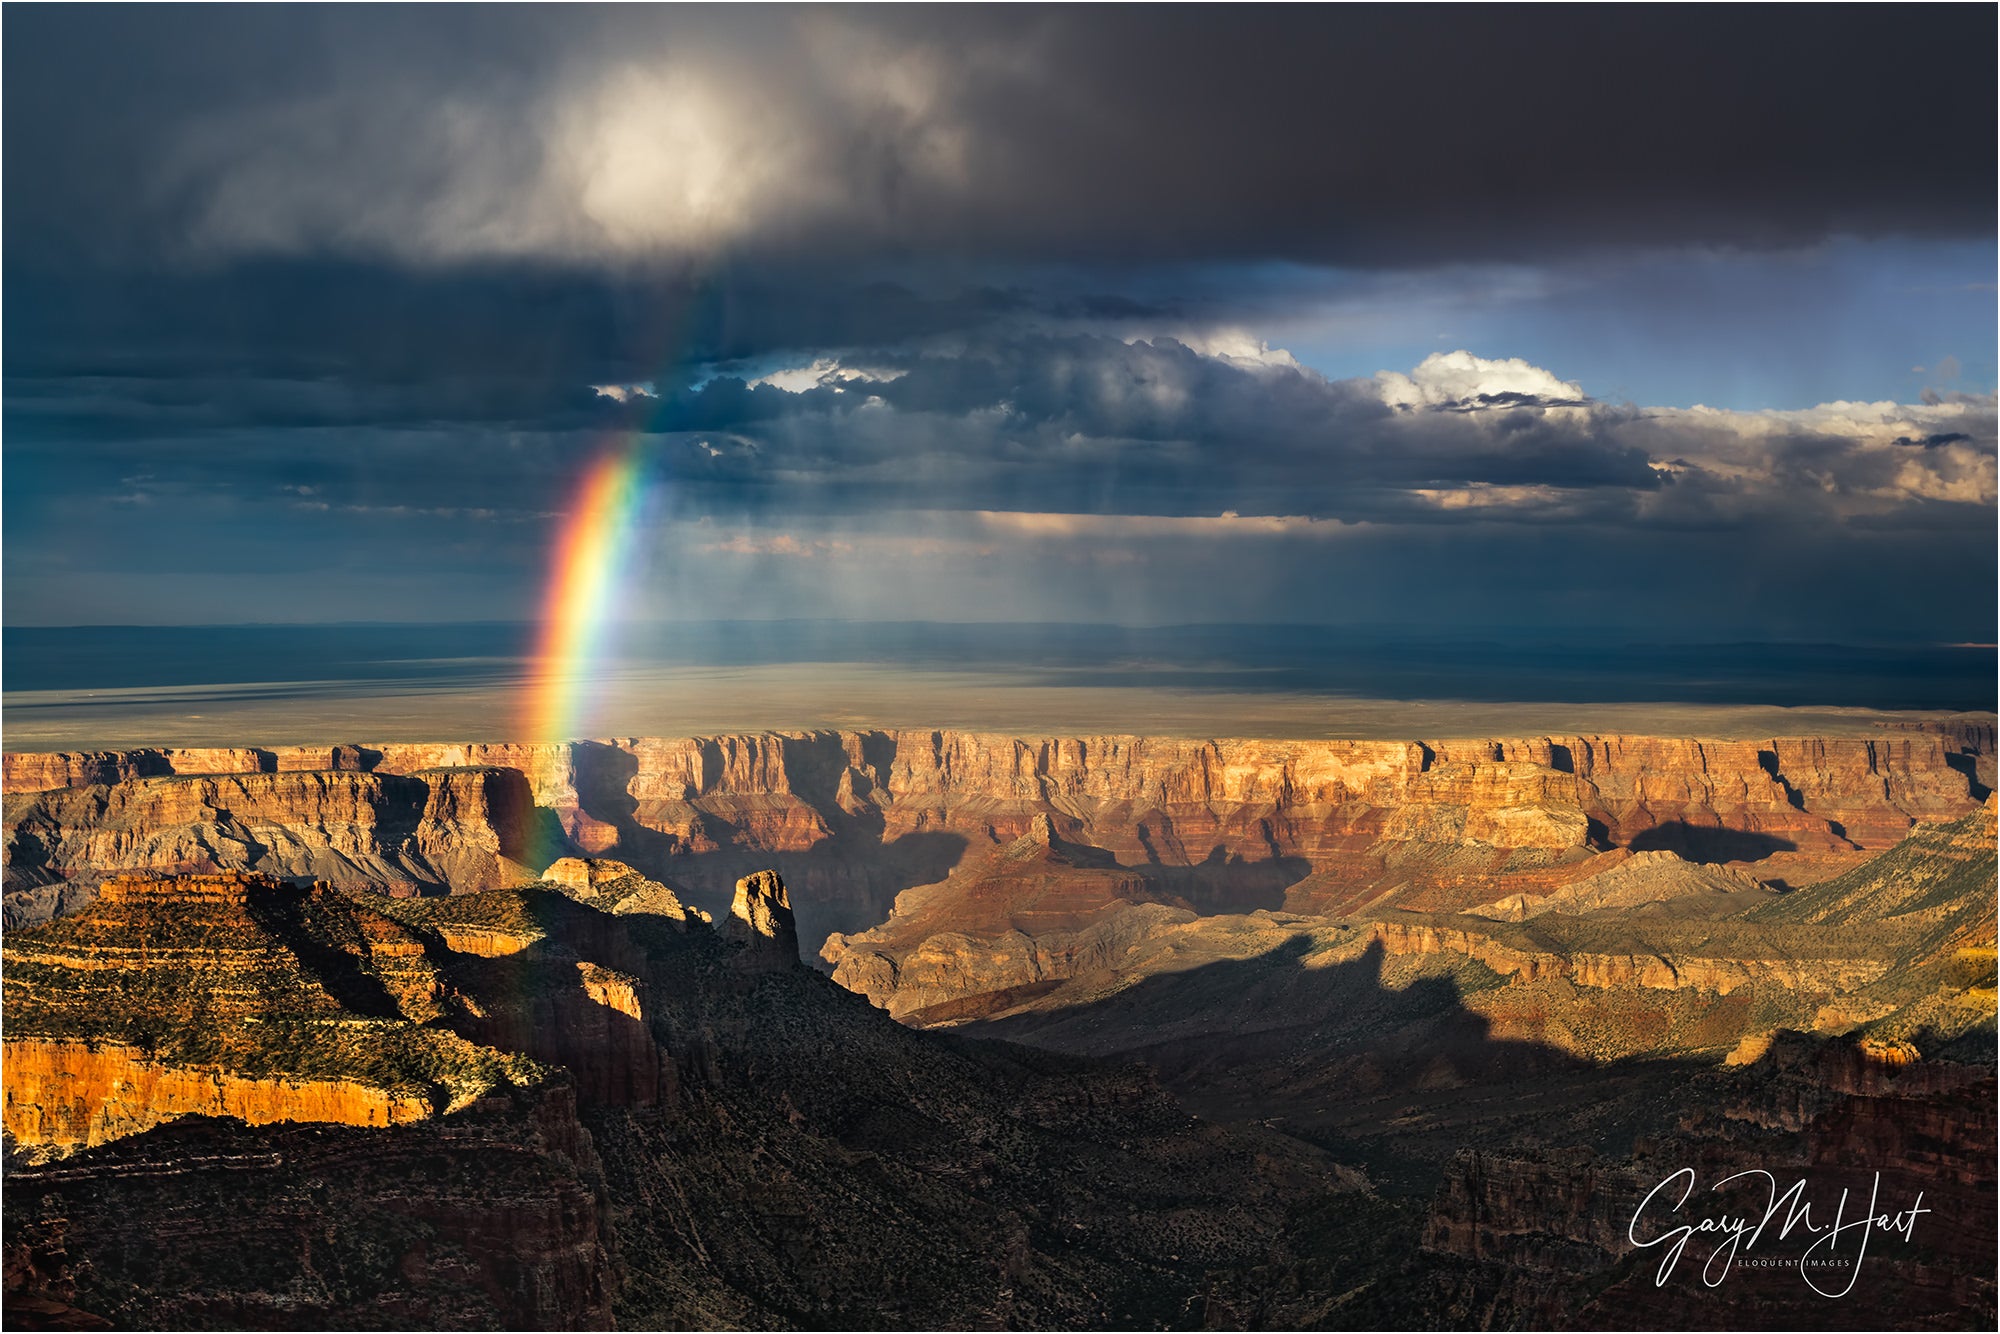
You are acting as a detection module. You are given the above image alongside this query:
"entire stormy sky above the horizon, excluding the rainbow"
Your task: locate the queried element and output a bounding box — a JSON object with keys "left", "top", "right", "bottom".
{"left": 0, "top": 4, "right": 1996, "bottom": 644}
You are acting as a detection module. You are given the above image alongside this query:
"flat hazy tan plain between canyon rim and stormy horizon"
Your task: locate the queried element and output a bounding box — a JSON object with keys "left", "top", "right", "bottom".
{"left": 0, "top": 624, "right": 1994, "bottom": 750}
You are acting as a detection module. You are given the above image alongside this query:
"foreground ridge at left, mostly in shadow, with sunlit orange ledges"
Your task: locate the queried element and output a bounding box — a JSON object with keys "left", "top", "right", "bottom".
{"left": 4, "top": 862, "right": 1352, "bottom": 1328}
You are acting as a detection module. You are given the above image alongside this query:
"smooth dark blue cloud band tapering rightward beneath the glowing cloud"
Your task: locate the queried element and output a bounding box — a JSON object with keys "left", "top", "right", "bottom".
{"left": 6, "top": 264, "right": 1032, "bottom": 386}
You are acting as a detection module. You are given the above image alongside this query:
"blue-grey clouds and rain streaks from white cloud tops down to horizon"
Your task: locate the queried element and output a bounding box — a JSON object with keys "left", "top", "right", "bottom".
{"left": 8, "top": 336, "right": 1996, "bottom": 638}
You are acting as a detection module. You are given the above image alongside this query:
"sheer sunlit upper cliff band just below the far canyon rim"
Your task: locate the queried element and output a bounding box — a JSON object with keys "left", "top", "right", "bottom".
{"left": 11, "top": 722, "right": 1994, "bottom": 844}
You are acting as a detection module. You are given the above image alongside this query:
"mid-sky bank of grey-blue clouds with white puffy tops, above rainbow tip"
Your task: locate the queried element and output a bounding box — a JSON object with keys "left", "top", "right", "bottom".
{"left": 8, "top": 336, "right": 1994, "bottom": 528}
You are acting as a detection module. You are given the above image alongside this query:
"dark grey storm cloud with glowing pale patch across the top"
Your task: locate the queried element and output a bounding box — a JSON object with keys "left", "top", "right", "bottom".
{"left": 6, "top": 6, "right": 1996, "bottom": 264}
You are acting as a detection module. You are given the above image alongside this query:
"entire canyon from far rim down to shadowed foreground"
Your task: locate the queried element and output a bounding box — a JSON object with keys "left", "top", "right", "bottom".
{"left": 0, "top": 716, "right": 1996, "bottom": 1328}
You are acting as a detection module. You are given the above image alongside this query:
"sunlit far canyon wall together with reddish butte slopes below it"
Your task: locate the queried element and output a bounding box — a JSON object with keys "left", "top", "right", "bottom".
{"left": 6, "top": 724, "right": 1992, "bottom": 1056}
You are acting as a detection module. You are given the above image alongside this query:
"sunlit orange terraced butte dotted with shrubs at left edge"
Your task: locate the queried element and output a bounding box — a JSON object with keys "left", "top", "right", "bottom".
{"left": 0, "top": 872, "right": 544, "bottom": 1156}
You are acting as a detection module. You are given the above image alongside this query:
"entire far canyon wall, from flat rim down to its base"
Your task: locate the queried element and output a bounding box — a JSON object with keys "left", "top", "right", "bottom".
{"left": 0, "top": 720, "right": 1994, "bottom": 948}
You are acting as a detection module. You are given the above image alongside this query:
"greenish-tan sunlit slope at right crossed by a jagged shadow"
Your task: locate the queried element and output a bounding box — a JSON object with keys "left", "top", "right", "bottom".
{"left": 912, "top": 802, "right": 1996, "bottom": 1090}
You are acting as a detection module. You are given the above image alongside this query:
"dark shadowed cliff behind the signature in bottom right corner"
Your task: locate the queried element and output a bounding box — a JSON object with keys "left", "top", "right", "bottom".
{"left": 1422, "top": 1034, "right": 1996, "bottom": 1328}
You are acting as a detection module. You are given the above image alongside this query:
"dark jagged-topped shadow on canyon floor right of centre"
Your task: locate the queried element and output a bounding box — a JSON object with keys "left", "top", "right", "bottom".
{"left": 958, "top": 936, "right": 1710, "bottom": 1196}
